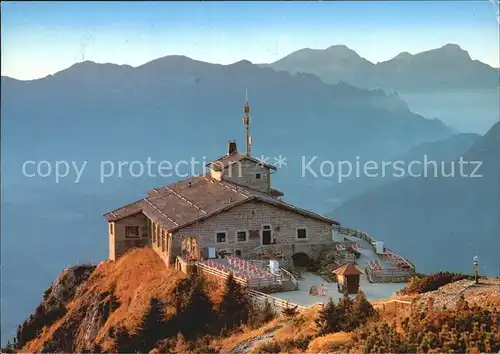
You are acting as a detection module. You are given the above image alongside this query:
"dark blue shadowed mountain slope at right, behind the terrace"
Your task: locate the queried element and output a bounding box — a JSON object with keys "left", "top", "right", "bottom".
{"left": 331, "top": 123, "right": 500, "bottom": 276}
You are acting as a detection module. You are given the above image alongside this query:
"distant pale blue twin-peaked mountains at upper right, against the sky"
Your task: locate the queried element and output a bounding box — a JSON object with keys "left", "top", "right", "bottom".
{"left": 262, "top": 44, "right": 499, "bottom": 91}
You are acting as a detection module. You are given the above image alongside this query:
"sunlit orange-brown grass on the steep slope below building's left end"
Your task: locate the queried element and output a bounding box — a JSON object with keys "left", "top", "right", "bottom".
{"left": 23, "top": 248, "right": 185, "bottom": 353}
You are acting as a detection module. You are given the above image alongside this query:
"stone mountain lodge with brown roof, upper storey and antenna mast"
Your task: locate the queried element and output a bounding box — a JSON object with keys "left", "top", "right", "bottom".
{"left": 104, "top": 101, "right": 338, "bottom": 265}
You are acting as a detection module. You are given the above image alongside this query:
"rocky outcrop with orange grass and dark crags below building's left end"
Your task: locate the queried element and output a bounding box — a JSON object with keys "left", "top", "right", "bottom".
{"left": 15, "top": 248, "right": 188, "bottom": 353}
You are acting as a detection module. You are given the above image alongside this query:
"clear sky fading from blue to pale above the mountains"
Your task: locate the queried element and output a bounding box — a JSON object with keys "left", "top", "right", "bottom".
{"left": 1, "top": 0, "right": 499, "bottom": 80}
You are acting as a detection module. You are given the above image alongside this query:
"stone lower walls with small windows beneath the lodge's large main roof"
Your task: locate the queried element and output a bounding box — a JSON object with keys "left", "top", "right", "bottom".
{"left": 109, "top": 201, "right": 333, "bottom": 266}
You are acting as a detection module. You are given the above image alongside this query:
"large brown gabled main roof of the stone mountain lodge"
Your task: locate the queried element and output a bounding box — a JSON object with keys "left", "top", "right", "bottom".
{"left": 104, "top": 175, "right": 338, "bottom": 232}
